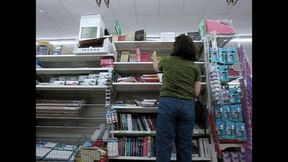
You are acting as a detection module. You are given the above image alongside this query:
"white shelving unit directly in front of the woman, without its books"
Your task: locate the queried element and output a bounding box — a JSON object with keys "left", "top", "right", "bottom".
{"left": 109, "top": 41, "right": 212, "bottom": 161}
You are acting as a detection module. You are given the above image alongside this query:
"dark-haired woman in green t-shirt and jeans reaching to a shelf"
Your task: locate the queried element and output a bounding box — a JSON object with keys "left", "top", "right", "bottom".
{"left": 152, "top": 34, "right": 201, "bottom": 162}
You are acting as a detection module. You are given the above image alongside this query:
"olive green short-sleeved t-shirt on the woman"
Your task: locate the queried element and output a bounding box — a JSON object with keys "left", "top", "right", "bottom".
{"left": 159, "top": 56, "right": 201, "bottom": 99}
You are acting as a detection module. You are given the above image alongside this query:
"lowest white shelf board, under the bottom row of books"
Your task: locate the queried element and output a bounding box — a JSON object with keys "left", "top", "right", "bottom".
{"left": 109, "top": 156, "right": 211, "bottom": 161}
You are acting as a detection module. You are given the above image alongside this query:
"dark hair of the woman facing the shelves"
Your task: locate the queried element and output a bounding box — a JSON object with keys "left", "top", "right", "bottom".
{"left": 171, "top": 34, "right": 197, "bottom": 61}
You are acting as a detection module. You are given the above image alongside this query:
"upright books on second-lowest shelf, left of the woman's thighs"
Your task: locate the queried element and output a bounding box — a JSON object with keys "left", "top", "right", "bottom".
{"left": 116, "top": 114, "right": 156, "bottom": 131}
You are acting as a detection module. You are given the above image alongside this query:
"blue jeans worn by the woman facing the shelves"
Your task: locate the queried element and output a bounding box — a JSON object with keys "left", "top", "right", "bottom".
{"left": 156, "top": 97, "right": 195, "bottom": 162}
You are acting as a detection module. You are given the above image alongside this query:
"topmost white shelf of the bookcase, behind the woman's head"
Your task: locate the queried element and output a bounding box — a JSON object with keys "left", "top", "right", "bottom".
{"left": 114, "top": 41, "right": 203, "bottom": 51}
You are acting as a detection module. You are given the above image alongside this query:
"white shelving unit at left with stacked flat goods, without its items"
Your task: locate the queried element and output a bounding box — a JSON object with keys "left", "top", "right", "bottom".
{"left": 35, "top": 53, "right": 115, "bottom": 144}
